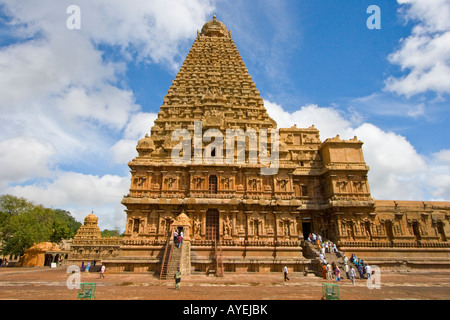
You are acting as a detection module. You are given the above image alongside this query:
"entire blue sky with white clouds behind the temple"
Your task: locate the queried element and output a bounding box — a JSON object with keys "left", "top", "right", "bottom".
{"left": 0, "top": 0, "right": 450, "bottom": 229}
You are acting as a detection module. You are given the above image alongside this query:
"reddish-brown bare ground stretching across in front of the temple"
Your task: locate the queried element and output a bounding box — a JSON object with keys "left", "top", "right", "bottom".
{"left": 0, "top": 267, "right": 450, "bottom": 301}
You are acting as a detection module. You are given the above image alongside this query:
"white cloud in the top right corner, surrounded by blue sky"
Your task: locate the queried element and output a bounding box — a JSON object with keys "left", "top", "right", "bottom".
{"left": 385, "top": 0, "right": 450, "bottom": 97}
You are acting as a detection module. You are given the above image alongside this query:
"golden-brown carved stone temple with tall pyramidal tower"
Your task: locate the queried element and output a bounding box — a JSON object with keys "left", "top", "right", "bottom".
{"left": 69, "top": 16, "right": 450, "bottom": 278}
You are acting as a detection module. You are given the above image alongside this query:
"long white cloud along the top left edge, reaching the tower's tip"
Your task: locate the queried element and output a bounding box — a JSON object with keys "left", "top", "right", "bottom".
{"left": 2, "top": 0, "right": 214, "bottom": 70}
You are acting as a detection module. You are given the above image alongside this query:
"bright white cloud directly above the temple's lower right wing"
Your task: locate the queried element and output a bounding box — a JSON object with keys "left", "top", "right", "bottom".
{"left": 264, "top": 101, "right": 450, "bottom": 200}
